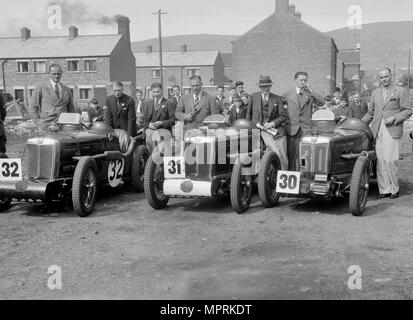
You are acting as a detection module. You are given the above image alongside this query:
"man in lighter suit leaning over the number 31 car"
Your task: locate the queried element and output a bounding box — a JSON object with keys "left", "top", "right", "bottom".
{"left": 175, "top": 76, "right": 218, "bottom": 130}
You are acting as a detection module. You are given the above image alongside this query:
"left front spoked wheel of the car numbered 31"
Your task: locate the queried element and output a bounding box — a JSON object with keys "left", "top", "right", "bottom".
{"left": 144, "top": 156, "right": 169, "bottom": 210}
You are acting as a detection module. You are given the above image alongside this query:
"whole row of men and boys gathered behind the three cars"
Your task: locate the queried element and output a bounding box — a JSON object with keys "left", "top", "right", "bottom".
{"left": 0, "top": 64, "right": 412, "bottom": 199}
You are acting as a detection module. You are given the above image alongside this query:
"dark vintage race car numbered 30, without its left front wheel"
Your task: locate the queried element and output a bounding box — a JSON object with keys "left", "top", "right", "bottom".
{"left": 275, "top": 110, "right": 377, "bottom": 216}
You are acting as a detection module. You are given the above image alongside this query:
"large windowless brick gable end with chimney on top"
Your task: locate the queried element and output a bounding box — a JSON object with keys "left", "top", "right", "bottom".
{"left": 232, "top": 0, "right": 338, "bottom": 94}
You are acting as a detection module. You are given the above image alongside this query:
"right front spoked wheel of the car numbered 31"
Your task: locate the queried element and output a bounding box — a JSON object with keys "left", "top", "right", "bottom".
{"left": 230, "top": 163, "right": 253, "bottom": 214}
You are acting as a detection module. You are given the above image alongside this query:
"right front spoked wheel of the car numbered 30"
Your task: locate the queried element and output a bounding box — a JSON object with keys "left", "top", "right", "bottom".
{"left": 349, "top": 157, "right": 371, "bottom": 216}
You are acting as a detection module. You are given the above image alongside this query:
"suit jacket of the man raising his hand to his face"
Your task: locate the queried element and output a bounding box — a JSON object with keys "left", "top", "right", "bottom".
{"left": 284, "top": 87, "right": 324, "bottom": 136}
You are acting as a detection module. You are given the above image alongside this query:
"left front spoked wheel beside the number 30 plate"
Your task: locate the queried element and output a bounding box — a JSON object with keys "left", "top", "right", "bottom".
{"left": 258, "top": 151, "right": 281, "bottom": 208}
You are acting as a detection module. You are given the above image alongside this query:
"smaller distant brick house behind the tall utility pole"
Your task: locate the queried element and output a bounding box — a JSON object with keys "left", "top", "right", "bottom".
{"left": 134, "top": 45, "right": 227, "bottom": 97}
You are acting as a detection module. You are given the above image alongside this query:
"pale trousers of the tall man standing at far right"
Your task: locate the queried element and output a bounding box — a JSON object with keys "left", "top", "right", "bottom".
{"left": 376, "top": 120, "right": 401, "bottom": 194}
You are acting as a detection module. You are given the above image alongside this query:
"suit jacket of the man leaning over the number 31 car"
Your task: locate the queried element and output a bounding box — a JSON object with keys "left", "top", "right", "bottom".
{"left": 175, "top": 91, "right": 218, "bottom": 130}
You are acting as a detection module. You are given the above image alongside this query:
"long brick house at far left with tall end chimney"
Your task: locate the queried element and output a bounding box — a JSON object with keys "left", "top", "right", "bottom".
{"left": 0, "top": 17, "right": 136, "bottom": 112}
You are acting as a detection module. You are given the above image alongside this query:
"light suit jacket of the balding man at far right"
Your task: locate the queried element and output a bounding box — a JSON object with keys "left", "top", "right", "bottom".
{"left": 361, "top": 86, "right": 412, "bottom": 139}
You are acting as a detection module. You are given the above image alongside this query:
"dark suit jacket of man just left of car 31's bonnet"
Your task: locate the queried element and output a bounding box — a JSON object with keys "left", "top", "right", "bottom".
{"left": 143, "top": 97, "right": 175, "bottom": 130}
